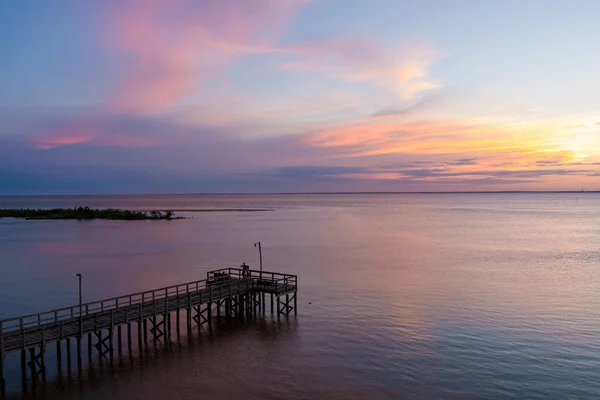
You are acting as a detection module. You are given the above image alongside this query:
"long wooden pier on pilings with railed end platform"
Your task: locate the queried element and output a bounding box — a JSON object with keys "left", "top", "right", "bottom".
{"left": 0, "top": 268, "right": 298, "bottom": 398}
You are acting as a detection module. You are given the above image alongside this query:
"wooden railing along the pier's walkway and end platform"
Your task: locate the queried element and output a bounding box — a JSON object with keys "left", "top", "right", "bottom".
{"left": 0, "top": 268, "right": 297, "bottom": 333}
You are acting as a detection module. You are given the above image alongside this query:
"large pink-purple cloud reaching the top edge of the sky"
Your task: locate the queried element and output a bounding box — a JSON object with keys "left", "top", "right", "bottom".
{"left": 105, "top": 0, "right": 306, "bottom": 112}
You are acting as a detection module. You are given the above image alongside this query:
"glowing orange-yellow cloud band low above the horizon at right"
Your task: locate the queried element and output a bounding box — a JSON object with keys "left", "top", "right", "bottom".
{"left": 304, "top": 112, "right": 598, "bottom": 179}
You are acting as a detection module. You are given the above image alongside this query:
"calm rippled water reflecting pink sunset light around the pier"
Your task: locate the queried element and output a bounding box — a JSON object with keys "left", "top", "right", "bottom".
{"left": 0, "top": 194, "right": 600, "bottom": 400}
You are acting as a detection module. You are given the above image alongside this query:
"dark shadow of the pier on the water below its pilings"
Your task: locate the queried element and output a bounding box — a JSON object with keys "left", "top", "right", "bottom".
{"left": 6, "top": 311, "right": 298, "bottom": 399}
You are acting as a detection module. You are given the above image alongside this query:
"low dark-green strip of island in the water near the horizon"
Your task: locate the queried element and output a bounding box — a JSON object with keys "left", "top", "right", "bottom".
{"left": 0, "top": 207, "right": 184, "bottom": 220}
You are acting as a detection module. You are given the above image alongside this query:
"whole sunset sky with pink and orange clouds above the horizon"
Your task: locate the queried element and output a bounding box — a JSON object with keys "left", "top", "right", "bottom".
{"left": 0, "top": 0, "right": 600, "bottom": 195}
